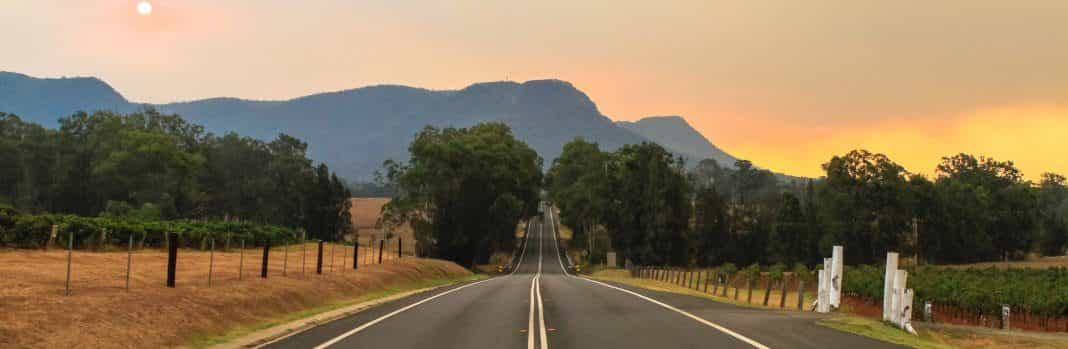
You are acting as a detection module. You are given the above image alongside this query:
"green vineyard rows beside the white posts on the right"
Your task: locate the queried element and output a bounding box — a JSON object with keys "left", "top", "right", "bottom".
{"left": 843, "top": 266, "right": 1068, "bottom": 331}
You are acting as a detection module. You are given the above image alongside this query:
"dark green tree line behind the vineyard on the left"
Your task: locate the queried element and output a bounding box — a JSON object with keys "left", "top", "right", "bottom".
{"left": 0, "top": 109, "right": 351, "bottom": 239}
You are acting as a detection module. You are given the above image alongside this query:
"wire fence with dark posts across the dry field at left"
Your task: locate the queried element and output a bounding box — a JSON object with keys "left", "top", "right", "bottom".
{"left": 15, "top": 236, "right": 415, "bottom": 296}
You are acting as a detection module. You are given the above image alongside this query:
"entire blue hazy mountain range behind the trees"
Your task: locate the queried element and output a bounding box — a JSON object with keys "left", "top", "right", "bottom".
{"left": 0, "top": 72, "right": 768, "bottom": 179}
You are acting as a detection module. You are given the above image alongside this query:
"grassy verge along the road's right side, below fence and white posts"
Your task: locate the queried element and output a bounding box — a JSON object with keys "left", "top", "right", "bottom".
{"left": 586, "top": 269, "right": 1068, "bottom": 349}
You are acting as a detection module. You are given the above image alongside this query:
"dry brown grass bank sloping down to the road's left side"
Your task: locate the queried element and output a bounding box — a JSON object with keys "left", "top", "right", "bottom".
{"left": 0, "top": 245, "right": 470, "bottom": 348}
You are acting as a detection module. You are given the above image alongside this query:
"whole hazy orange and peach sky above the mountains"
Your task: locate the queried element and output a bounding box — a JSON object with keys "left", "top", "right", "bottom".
{"left": 0, "top": 0, "right": 1068, "bottom": 179}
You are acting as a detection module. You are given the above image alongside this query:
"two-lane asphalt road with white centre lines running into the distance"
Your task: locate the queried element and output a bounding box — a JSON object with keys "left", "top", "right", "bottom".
{"left": 265, "top": 204, "right": 899, "bottom": 349}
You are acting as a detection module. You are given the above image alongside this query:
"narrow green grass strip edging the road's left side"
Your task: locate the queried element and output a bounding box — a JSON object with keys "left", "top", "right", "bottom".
{"left": 187, "top": 274, "right": 488, "bottom": 348}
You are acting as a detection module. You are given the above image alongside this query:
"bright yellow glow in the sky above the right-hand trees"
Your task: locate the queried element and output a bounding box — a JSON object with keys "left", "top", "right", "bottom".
{"left": 728, "top": 106, "right": 1068, "bottom": 181}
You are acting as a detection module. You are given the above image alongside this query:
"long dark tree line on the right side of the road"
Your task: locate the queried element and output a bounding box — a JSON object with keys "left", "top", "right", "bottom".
{"left": 546, "top": 139, "right": 1068, "bottom": 267}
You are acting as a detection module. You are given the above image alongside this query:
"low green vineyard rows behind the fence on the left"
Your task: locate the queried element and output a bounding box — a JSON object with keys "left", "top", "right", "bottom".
{"left": 0, "top": 208, "right": 300, "bottom": 249}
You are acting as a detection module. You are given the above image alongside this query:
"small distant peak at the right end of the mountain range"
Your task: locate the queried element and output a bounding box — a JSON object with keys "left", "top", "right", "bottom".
{"left": 615, "top": 116, "right": 737, "bottom": 166}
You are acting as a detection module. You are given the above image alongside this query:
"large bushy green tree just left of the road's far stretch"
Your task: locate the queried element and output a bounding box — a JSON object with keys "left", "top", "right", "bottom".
{"left": 383, "top": 123, "right": 541, "bottom": 266}
